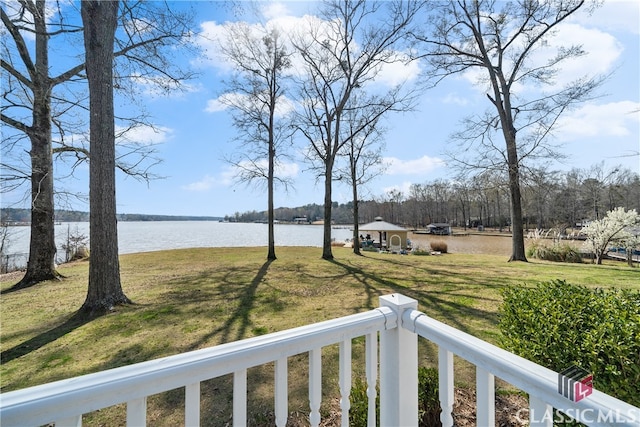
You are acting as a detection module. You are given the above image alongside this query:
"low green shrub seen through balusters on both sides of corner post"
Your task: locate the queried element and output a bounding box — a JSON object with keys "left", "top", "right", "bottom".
{"left": 349, "top": 367, "right": 442, "bottom": 427}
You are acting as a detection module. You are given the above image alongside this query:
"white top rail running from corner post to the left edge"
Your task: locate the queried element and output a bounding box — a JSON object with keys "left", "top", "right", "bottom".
{"left": 0, "top": 307, "right": 397, "bottom": 426}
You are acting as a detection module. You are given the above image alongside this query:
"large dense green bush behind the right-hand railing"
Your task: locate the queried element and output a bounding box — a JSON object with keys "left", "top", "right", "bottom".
{"left": 500, "top": 280, "right": 640, "bottom": 406}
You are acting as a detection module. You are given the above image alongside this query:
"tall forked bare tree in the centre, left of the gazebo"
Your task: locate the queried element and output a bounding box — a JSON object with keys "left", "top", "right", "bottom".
{"left": 293, "top": 0, "right": 421, "bottom": 259}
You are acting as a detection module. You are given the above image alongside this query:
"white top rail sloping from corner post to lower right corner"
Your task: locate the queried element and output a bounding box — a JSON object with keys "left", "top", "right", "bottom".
{"left": 402, "top": 310, "right": 640, "bottom": 427}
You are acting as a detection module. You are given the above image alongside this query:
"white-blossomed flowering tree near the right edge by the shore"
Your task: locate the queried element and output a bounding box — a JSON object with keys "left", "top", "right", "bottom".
{"left": 582, "top": 207, "right": 640, "bottom": 264}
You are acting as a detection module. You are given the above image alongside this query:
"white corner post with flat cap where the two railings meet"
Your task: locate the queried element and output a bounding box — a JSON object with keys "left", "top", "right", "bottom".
{"left": 380, "top": 294, "right": 418, "bottom": 426}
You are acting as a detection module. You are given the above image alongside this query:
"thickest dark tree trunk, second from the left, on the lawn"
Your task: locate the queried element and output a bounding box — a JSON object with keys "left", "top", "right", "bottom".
{"left": 80, "top": 1, "right": 131, "bottom": 316}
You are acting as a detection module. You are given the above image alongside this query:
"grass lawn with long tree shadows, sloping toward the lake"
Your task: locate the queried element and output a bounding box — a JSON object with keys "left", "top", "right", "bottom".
{"left": 0, "top": 247, "right": 640, "bottom": 425}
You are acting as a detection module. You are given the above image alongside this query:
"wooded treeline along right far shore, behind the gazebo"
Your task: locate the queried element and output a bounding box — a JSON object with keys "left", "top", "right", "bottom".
{"left": 225, "top": 165, "right": 640, "bottom": 229}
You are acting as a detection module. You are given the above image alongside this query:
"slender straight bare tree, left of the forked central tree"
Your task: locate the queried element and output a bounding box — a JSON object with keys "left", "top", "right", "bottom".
{"left": 220, "top": 22, "right": 291, "bottom": 260}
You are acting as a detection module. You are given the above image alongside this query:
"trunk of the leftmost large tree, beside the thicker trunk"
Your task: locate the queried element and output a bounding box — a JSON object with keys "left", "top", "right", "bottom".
{"left": 13, "top": 1, "right": 59, "bottom": 289}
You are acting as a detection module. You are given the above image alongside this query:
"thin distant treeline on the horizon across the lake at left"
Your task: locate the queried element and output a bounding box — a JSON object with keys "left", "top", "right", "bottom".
{"left": 0, "top": 208, "right": 222, "bottom": 224}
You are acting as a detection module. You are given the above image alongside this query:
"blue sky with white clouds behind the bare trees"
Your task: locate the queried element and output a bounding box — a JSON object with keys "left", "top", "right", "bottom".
{"left": 2, "top": 0, "right": 640, "bottom": 217}
